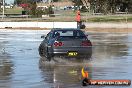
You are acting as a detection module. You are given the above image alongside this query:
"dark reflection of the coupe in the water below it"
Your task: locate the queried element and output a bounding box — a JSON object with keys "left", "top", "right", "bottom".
{"left": 39, "top": 52, "right": 92, "bottom": 88}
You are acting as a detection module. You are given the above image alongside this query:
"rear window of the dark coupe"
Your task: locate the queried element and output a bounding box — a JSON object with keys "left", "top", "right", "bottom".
{"left": 53, "top": 30, "right": 86, "bottom": 38}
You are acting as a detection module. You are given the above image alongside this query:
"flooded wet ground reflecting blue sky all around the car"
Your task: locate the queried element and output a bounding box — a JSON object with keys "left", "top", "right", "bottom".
{"left": 0, "top": 29, "right": 132, "bottom": 88}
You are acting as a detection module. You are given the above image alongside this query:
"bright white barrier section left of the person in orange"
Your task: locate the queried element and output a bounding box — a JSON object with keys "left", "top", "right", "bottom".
{"left": 0, "top": 22, "right": 77, "bottom": 28}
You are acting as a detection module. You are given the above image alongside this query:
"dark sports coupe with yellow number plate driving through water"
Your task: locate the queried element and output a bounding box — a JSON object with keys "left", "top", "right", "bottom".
{"left": 39, "top": 29, "right": 92, "bottom": 61}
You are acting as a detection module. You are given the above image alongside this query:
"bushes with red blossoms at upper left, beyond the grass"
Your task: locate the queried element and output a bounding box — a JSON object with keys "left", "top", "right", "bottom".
{"left": 14, "top": 0, "right": 54, "bottom": 17}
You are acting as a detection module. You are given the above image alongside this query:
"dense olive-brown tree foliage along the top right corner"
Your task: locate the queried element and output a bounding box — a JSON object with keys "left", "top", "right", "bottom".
{"left": 72, "top": 0, "right": 132, "bottom": 14}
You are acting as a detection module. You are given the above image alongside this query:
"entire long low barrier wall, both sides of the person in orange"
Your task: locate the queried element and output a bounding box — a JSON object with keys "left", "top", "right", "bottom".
{"left": 0, "top": 22, "right": 132, "bottom": 28}
